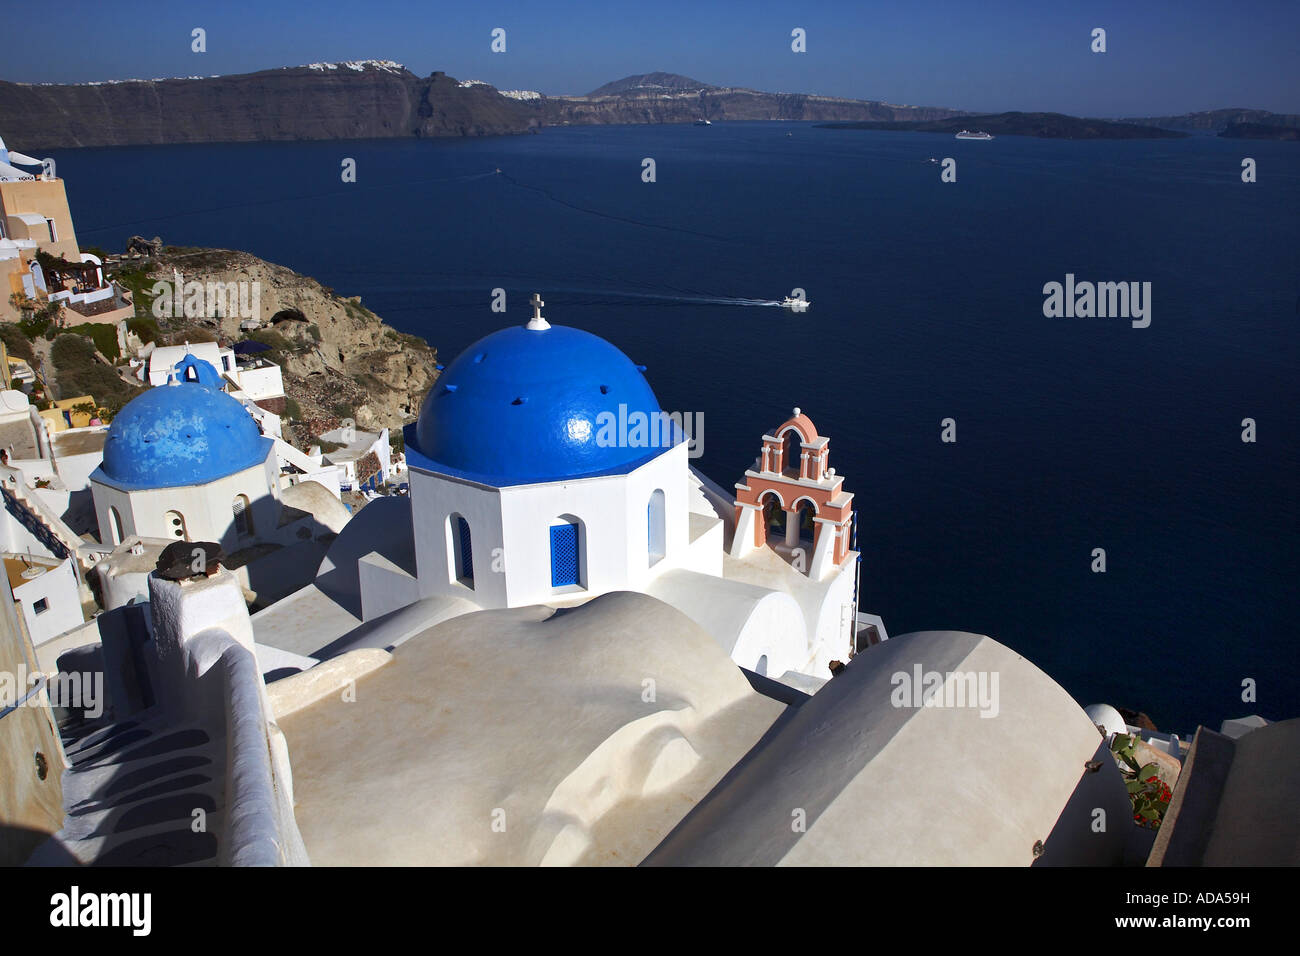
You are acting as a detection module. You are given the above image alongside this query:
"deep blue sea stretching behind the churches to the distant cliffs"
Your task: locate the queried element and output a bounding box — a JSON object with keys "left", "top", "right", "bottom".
{"left": 48, "top": 124, "right": 1300, "bottom": 734}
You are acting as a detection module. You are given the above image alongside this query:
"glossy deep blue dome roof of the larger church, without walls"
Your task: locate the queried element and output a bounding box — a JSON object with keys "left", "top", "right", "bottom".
{"left": 407, "top": 325, "right": 681, "bottom": 486}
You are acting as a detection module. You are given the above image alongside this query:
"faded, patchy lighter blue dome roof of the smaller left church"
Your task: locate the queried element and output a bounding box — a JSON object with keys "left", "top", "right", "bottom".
{"left": 100, "top": 379, "right": 273, "bottom": 490}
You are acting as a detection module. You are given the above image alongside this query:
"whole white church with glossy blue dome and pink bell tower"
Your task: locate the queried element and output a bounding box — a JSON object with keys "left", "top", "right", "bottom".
{"left": 245, "top": 295, "right": 863, "bottom": 678}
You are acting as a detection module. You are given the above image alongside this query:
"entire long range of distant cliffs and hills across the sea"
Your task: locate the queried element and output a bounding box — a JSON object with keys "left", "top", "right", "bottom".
{"left": 0, "top": 60, "right": 961, "bottom": 147}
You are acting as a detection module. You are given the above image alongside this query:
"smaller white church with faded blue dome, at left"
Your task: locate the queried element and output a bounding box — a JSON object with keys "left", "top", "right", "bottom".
{"left": 90, "top": 355, "right": 280, "bottom": 553}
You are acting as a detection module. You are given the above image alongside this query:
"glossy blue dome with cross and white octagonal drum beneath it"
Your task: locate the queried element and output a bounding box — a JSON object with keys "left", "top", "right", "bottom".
{"left": 406, "top": 297, "right": 689, "bottom": 607}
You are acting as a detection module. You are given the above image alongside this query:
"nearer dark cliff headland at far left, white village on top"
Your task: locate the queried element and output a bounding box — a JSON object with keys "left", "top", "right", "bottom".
{"left": 0, "top": 60, "right": 530, "bottom": 150}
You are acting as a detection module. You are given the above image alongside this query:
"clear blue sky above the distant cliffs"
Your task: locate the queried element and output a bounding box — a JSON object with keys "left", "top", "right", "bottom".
{"left": 0, "top": 0, "right": 1300, "bottom": 116}
